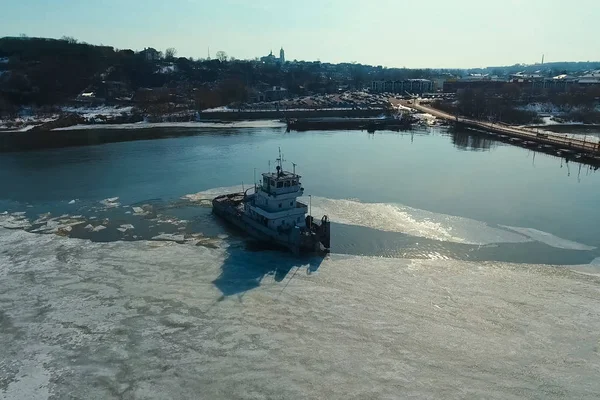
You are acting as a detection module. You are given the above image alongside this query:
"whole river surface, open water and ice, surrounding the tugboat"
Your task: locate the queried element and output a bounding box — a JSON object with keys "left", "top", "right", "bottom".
{"left": 0, "top": 124, "right": 600, "bottom": 399}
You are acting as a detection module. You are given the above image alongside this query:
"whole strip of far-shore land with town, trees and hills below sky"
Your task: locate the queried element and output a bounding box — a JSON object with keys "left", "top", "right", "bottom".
{"left": 0, "top": 36, "right": 600, "bottom": 130}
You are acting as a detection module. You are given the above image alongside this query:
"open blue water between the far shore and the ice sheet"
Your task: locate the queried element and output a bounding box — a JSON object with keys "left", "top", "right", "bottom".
{"left": 0, "top": 124, "right": 600, "bottom": 264}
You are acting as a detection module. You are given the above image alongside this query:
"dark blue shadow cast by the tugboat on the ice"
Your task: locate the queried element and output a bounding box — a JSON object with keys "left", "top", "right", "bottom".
{"left": 213, "top": 241, "right": 324, "bottom": 297}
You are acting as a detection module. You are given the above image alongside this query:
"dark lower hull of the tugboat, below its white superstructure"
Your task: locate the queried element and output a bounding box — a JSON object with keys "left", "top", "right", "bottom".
{"left": 212, "top": 192, "right": 330, "bottom": 254}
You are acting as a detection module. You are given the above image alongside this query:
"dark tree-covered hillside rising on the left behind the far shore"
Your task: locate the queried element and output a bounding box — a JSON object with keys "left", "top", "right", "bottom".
{"left": 0, "top": 37, "right": 440, "bottom": 113}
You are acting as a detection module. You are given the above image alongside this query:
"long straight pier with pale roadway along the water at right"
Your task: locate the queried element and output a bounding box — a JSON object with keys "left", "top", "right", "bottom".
{"left": 401, "top": 99, "right": 600, "bottom": 165}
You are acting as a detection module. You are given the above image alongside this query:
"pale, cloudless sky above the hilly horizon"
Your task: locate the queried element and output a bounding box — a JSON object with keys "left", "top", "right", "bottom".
{"left": 0, "top": 0, "right": 600, "bottom": 68}
